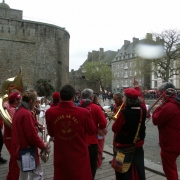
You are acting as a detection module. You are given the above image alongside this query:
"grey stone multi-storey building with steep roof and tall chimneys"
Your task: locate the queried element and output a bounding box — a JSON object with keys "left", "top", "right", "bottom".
{"left": 112, "top": 33, "right": 162, "bottom": 93}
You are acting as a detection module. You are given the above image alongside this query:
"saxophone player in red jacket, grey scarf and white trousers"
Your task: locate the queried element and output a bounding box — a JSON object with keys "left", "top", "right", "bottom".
{"left": 11, "top": 90, "right": 49, "bottom": 180}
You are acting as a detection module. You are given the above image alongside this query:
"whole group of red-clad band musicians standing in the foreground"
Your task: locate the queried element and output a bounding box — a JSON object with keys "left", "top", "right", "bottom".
{"left": 0, "top": 78, "right": 180, "bottom": 180}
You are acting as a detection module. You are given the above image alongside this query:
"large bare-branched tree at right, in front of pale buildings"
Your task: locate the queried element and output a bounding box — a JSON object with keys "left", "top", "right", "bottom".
{"left": 135, "top": 29, "right": 180, "bottom": 81}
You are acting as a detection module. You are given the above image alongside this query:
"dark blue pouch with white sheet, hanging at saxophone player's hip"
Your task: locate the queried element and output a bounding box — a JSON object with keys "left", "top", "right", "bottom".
{"left": 19, "top": 146, "right": 37, "bottom": 172}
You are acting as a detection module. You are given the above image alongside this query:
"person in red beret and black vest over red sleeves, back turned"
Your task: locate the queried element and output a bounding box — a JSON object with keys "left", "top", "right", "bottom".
{"left": 112, "top": 78, "right": 146, "bottom": 180}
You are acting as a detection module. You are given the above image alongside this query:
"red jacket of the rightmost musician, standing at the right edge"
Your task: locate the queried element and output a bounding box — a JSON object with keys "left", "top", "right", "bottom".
{"left": 152, "top": 97, "right": 180, "bottom": 153}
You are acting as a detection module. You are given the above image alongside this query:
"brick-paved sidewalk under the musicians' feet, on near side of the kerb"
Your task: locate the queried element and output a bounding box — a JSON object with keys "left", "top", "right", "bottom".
{"left": 0, "top": 146, "right": 166, "bottom": 180}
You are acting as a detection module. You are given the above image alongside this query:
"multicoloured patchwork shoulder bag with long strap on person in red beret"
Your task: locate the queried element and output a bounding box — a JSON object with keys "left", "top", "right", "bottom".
{"left": 111, "top": 109, "right": 142, "bottom": 173}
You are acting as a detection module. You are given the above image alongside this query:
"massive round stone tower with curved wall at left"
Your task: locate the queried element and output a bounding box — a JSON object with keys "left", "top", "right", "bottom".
{"left": 0, "top": 1, "right": 70, "bottom": 90}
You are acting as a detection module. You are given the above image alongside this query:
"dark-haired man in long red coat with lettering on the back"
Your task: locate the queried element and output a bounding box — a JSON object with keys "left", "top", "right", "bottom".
{"left": 45, "top": 85, "right": 96, "bottom": 180}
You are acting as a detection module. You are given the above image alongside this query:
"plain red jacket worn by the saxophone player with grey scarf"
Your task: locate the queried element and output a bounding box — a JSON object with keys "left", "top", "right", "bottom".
{"left": 11, "top": 107, "right": 44, "bottom": 163}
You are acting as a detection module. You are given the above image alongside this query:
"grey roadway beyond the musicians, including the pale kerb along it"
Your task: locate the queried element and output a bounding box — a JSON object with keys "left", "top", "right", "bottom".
{"left": 100, "top": 100, "right": 180, "bottom": 178}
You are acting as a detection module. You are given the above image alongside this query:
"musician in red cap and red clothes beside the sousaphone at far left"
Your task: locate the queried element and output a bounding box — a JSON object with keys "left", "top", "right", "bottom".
{"left": 3, "top": 92, "right": 21, "bottom": 180}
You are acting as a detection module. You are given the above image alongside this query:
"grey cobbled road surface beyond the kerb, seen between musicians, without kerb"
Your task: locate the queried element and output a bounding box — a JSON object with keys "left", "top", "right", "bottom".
{"left": 101, "top": 100, "right": 180, "bottom": 171}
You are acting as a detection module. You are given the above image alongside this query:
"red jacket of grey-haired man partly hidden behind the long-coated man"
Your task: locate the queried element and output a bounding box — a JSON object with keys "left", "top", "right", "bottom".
{"left": 80, "top": 100, "right": 107, "bottom": 144}
